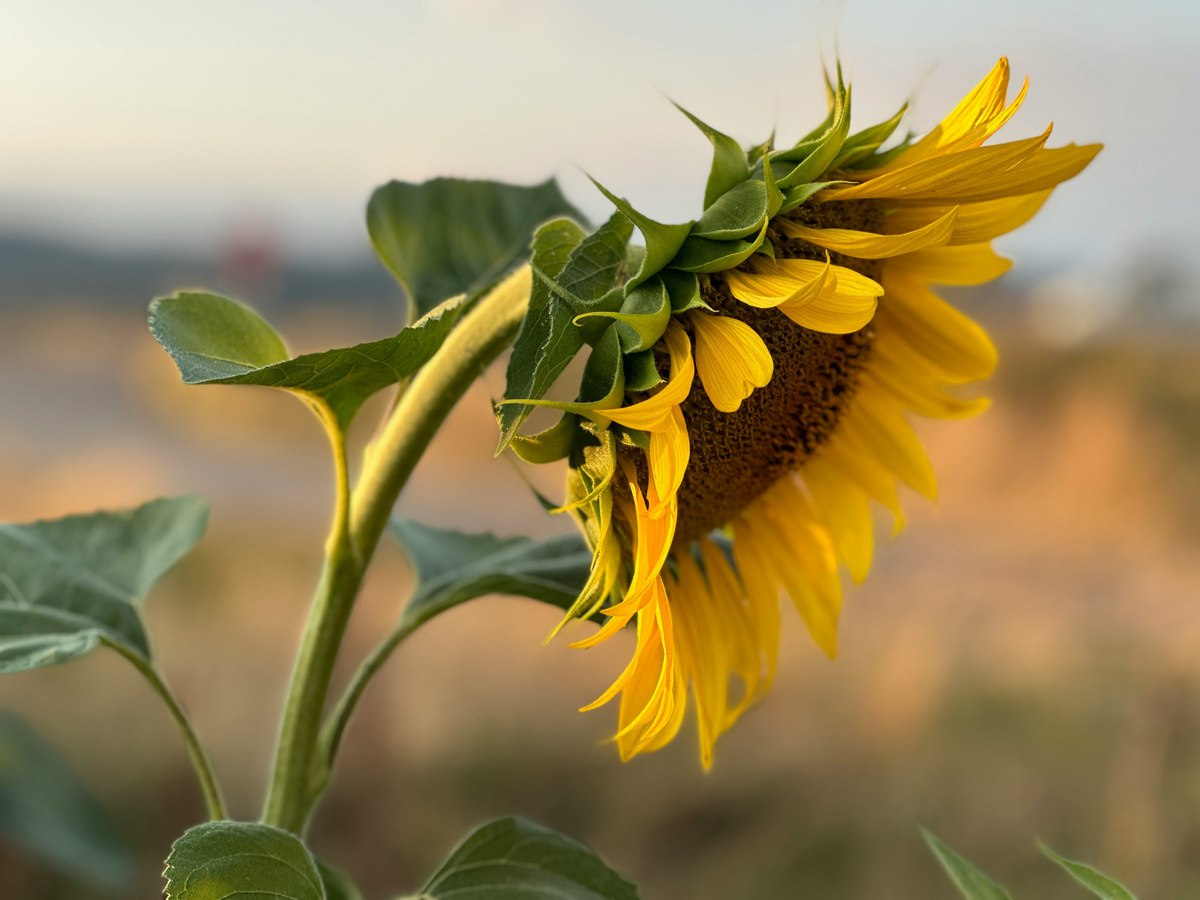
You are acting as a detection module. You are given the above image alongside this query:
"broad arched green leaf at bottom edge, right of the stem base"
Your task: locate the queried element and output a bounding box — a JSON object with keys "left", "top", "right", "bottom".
{"left": 419, "top": 818, "right": 637, "bottom": 900}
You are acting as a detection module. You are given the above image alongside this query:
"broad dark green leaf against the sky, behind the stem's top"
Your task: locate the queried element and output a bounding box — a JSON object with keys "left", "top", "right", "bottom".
{"left": 367, "top": 178, "right": 582, "bottom": 318}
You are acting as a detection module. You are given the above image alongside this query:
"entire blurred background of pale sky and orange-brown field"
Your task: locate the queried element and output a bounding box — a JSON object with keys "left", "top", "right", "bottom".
{"left": 0, "top": 0, "right": 1200, "bottom": 900}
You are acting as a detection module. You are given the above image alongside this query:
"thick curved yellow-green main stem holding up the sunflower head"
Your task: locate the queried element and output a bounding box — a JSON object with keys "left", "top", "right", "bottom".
{"left": 263, "top": 265, "right": 530, "bottom": 834}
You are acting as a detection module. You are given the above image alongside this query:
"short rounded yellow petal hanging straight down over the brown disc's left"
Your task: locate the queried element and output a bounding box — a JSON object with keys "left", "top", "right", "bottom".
{"left": 689, "top": 312, "right": 774, "bottom": 413}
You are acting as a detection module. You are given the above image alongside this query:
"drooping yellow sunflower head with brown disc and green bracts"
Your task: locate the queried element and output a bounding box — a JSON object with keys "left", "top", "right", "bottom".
{"left": 499, "top": 59, "right": 1100, "bottom": 768}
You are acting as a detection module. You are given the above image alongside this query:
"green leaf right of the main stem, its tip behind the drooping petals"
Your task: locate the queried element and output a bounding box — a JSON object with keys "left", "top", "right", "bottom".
{"left": 389, "top": 518, "right": 592, "bottom": 622}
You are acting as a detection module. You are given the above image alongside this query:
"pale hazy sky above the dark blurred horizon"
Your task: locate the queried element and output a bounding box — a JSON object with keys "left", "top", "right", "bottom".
{"left": 0, "top": 0, "right": 1200, "bottom": 277}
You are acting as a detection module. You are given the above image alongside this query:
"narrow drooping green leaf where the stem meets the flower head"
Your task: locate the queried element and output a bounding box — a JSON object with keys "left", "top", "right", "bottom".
{"left": 496, "top": 218, "right": 586, "bottom": 455}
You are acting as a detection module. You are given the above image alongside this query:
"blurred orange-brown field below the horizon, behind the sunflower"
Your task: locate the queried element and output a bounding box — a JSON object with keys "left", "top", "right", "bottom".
{"left": 0, "top": 300, "right": 1200, "bottom": 900}
